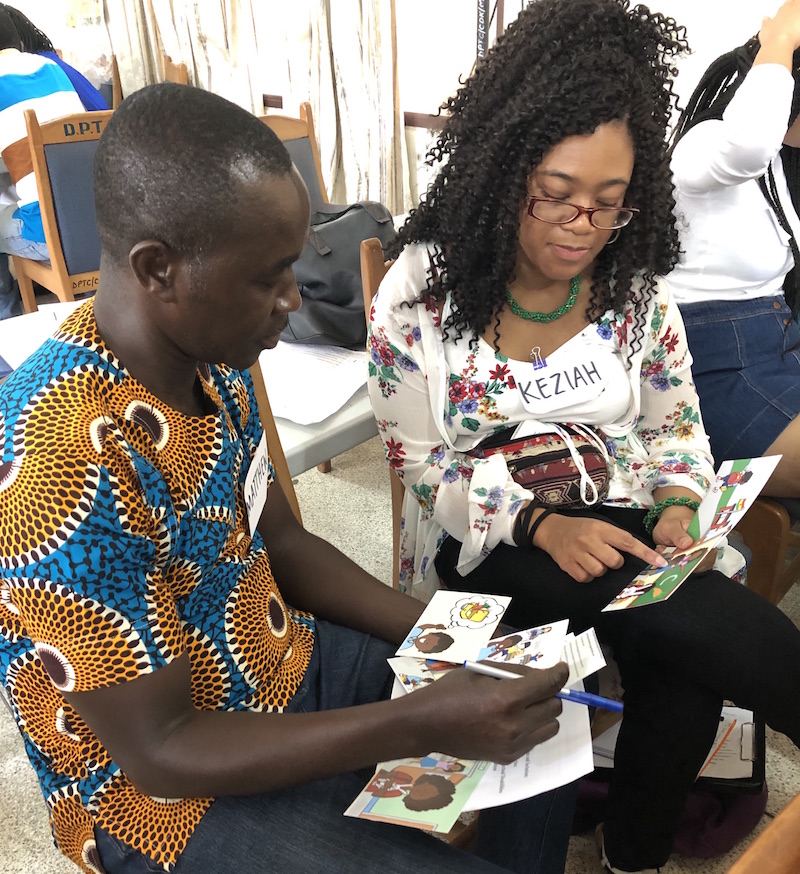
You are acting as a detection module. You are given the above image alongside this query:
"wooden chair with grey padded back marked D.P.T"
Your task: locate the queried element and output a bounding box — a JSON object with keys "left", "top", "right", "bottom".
{"left": 11, "top": 109, "right": 112, "bottom": 313}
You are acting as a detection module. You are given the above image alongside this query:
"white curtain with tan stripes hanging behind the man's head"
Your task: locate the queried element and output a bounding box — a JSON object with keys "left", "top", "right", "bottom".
{"left": 104, "top": 0, "right": 411, "bottom": 214}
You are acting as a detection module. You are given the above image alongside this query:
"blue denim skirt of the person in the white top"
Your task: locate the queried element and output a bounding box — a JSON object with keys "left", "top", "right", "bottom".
{"left": 681, "top": 297, "right": 800, "bottom": 460}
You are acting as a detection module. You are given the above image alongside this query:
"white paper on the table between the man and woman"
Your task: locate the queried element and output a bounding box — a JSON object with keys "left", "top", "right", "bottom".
{"left": 259, "top": 341, "right": 367, "bottom": 425}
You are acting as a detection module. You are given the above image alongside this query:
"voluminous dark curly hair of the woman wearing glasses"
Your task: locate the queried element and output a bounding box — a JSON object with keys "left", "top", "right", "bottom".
{"left": 389, "top": 0, "right": 688, "bottom": 358}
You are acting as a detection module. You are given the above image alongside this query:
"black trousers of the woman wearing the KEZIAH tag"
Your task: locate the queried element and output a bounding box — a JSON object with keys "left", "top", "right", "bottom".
{"left": 436, "top": 508, "right": 800, "bottom": 871}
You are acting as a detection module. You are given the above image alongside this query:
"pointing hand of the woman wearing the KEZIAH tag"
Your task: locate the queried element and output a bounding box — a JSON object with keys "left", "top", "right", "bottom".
{"left": 533, "top": 513, "right": 668, "bottom": 583}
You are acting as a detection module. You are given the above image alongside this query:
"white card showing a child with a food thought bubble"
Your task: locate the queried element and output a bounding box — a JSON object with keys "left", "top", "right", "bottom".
{"left": 397, "top": 589, "right": 511, "bottom": 663}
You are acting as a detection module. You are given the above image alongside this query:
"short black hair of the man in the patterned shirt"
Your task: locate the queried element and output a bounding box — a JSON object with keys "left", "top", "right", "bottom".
{"left": 94, "top": 82, "right": 292, "bottom": 264}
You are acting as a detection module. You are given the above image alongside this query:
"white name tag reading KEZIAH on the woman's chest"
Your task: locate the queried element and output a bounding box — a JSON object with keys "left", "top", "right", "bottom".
{"left": 514, "top": 346, "right": 608, "bottom": 414}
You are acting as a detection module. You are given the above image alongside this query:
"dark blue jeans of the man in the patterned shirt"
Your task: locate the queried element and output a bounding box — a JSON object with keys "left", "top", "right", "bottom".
{"left": 95, "top": 622, "right": 577, "bottom": 874}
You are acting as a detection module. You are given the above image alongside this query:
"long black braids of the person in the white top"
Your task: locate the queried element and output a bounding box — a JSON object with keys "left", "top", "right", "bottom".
{"left": 670, "top": 36, "right": 800, "bottom": 318}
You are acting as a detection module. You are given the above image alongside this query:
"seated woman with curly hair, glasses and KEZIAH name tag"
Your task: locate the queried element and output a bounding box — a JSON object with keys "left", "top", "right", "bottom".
{"left": 369, "top": 0, "right": 800, "bottom": 872}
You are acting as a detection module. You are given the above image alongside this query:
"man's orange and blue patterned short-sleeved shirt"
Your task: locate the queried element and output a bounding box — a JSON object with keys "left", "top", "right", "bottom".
{"left": 0, "top": 301, "right": 314, "bottom": 872}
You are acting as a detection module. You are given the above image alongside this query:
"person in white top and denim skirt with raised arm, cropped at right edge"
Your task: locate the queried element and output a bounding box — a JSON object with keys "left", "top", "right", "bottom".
{"left": 667, "top": 0, "right": 800, "bottom": 498}
